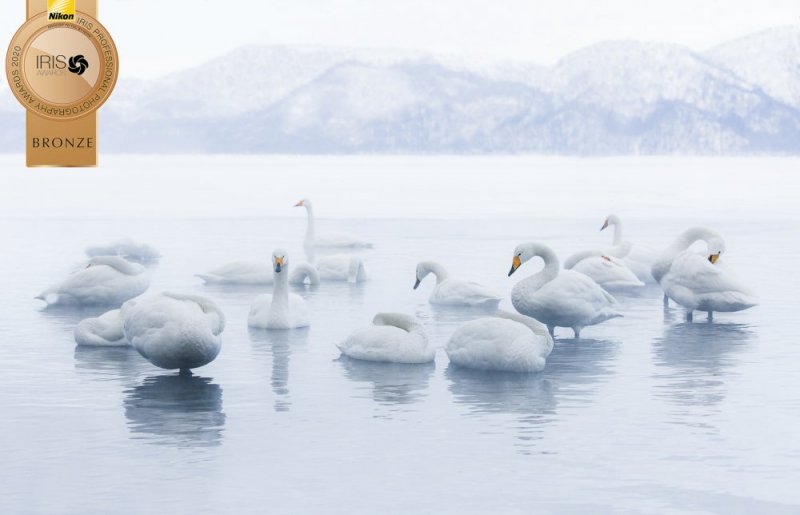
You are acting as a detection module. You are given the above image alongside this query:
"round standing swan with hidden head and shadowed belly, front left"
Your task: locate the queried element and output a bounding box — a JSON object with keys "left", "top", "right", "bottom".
{"left": 121, "top": 292, "right": 225, "bottom": 371}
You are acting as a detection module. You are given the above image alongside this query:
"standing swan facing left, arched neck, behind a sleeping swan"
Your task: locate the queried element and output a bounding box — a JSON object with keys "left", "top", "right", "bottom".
{"left": 508, "top": 243, "right": 622, "bottom": 338}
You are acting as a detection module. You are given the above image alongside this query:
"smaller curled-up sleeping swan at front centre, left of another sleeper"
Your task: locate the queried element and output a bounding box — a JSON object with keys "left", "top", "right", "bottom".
{"left": 337, "top": 313, "right": 436, "bottom": 364}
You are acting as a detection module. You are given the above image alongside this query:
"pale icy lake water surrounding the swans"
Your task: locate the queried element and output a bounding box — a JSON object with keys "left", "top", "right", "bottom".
{"left": 0, "top": 157, "right": 800, "bottom": 514}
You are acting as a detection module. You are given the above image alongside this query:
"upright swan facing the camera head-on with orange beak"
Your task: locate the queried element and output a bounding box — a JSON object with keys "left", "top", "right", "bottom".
{"left": 247, "top": 249, "right": 309, "bottom": 329}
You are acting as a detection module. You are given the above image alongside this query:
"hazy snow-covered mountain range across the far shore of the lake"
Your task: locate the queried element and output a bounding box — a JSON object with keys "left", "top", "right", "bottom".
{"left": 0, "top": 27, "right": 800, "bottom": 155}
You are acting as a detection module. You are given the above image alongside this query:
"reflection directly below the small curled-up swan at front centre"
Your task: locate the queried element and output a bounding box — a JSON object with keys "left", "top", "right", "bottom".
{"left": 337, "top": 356, "right": 436, "bottom": 407}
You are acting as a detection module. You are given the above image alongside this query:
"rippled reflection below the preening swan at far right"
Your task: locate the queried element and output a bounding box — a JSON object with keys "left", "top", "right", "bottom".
{"left": 653, "top": 322, "right": 753, "bottom": 425}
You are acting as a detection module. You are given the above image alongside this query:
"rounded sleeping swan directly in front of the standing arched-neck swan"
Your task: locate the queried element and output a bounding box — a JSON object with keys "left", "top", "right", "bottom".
{"left": 445, "top": 311, "right": 553, "bottom": 372}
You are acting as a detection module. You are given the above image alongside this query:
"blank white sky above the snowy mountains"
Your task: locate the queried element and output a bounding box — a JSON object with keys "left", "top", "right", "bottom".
{"left": 0, "top": 0, "right": 800, "bottom": 78}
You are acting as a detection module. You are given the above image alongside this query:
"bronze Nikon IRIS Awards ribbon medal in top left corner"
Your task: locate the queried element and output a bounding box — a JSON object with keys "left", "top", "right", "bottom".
{"left": 6, "top": 0, "right": 119, "bottom": 166}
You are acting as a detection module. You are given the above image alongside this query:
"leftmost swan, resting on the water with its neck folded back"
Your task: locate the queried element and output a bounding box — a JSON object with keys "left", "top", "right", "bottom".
{"left": 36, "top": 256, "right": 150, "bottom": 306}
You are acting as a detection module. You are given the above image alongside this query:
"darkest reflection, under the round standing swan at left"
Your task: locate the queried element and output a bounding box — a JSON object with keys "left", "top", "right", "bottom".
{"left": 125, "top": 374, "right": 225, "bottom": 447}
